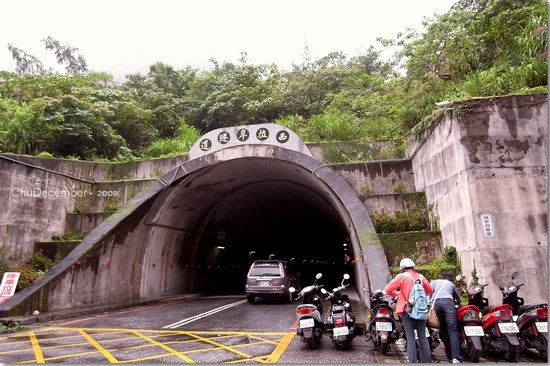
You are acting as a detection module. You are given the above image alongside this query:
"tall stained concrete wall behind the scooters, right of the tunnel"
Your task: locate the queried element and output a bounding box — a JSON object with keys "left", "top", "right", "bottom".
{"left": 410, "top": 94, "right": 548, "bottom": 303}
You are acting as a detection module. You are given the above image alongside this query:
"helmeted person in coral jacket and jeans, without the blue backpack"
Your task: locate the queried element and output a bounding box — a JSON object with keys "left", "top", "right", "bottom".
{"left": 384, "top": 258, "right": 433, "bottom": 363}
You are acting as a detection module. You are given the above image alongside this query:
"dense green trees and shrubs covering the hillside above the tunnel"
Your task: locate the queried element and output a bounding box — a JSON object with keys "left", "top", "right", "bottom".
{"left": 0, "top": 0, "right": 548, "bottom": 160}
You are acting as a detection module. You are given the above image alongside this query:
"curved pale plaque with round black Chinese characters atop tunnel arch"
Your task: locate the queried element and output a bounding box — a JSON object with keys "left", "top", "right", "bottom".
{"left": 189, "top": 123, "right": 312, "bottom": 159}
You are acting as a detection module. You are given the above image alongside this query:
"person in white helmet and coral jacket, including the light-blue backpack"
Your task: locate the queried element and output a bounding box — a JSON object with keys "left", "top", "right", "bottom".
{"left": 384, "top": 258, "right": 433, "bottom": 363}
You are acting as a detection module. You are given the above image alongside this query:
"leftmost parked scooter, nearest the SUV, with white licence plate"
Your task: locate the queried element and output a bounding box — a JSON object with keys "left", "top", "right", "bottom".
{"left": 289, "top": 273, "right": 324, "bottom": 349}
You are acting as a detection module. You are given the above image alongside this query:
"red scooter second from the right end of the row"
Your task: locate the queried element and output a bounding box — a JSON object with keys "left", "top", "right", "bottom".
{"left": 481, "top": 274, "right": 519, "bottom": 362}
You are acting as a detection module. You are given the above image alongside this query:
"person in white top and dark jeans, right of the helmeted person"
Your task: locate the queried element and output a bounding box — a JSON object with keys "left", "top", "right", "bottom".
{"left": 430, "top": 272, "right": 462, "bottom": 363}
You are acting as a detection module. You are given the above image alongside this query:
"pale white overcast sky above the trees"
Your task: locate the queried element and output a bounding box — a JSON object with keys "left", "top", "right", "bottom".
{"left": 0, "top": 0, "right": 457, "bottom": 80}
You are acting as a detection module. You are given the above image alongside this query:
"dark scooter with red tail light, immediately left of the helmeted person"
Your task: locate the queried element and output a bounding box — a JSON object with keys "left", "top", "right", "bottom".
{"left": 368, "top": 290, "right": 401, "bottom": 355}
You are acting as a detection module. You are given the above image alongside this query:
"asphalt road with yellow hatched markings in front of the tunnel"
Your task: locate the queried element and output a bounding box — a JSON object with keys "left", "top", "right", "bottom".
{"left": 0, "top": 296, "right": 541, "bottom": 364}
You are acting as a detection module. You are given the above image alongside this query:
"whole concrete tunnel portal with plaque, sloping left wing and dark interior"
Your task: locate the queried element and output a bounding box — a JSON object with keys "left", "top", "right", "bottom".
{"left": 0, "top": 124, "right": 389, "bottom": 316}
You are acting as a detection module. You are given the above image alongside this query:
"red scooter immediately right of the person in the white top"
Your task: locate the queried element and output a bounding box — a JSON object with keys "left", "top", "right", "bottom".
{"left": 456, "top": 276, "right": 489, "bottom": 362}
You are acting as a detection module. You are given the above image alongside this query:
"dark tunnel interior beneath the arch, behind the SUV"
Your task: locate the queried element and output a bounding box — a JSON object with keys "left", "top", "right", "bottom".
{"left": 153, "top": 157, "right": 355, "bottom": 294}
